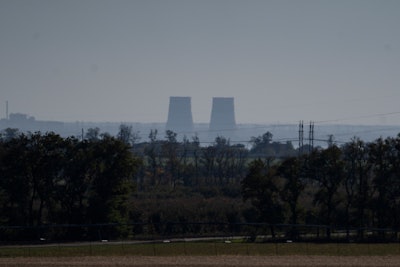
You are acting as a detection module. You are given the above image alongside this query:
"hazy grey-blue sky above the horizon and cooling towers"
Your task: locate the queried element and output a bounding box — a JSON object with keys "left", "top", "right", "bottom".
{"left": 0, "top": 0, "right": 400, "bottom": 125}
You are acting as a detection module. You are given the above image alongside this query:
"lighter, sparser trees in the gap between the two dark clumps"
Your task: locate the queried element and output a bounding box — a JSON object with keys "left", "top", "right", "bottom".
{"left": 133, "top": 130, "right": 296, "bottom": 190}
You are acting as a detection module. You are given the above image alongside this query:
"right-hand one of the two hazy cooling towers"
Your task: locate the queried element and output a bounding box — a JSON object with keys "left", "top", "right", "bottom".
{"left": 210, "top": 97, "right": 236, "bottom": 133}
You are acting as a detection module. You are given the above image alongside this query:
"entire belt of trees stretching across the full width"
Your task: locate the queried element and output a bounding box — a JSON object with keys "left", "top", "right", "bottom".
{"left": 0, "top": 125, "right": 400, "bottom": 242}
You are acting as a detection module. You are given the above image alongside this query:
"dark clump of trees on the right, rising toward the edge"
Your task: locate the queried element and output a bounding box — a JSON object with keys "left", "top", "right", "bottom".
{"left": 242, "top": 136, "right": 400, "bottom": 240}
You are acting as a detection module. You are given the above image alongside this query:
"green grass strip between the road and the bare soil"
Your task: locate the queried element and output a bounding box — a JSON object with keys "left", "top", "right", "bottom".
{"left": 0, "top": 241, "right": 400, "bottom": 258}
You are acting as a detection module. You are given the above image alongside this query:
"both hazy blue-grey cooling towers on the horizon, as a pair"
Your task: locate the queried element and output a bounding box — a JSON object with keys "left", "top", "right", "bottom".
{"left": 166, "top": 96, "right": 236, "bottom": 132}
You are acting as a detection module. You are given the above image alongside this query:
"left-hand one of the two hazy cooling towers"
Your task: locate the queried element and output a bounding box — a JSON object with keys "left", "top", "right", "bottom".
{"left": 166, "top": 96, "right": 193, "bottom": 133}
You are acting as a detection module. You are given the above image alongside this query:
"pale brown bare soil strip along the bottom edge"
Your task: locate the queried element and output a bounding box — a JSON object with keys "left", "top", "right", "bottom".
{"left": 0, "top": 256, "right": 400, "bottom": 267}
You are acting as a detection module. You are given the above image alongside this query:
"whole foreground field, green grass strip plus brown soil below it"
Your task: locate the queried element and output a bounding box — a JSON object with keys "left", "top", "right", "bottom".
{"left": 0, "top": 243, "right": 400, "bottom": 267}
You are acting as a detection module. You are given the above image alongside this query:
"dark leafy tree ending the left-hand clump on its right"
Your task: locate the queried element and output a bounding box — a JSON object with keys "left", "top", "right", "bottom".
{"left": 88, "top": 138, "right": 138, "bottom": 237}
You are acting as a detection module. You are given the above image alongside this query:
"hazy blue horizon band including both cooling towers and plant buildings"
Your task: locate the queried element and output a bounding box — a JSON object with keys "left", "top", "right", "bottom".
{"left": 0, "top": 97, "right": 398, "bottom": 147}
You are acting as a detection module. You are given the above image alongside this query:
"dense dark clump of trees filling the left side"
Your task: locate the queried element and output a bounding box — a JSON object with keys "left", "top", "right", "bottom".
{"left": 0, "top": 130, "right": 140, "bottom": 241}
